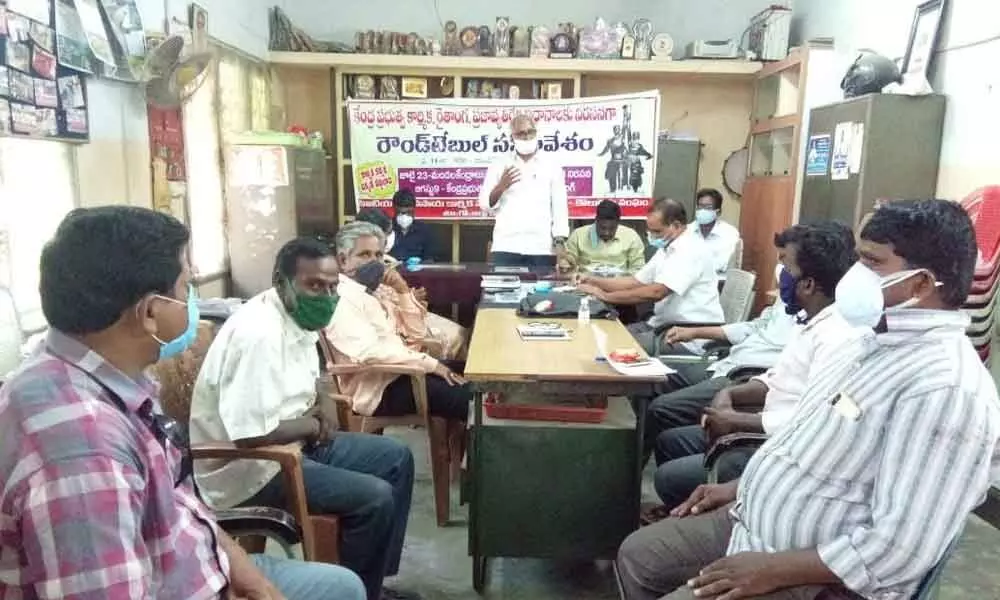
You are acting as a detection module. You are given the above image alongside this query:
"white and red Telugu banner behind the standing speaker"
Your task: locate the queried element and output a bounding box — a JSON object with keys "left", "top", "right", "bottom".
{"left": 347, "top": 91, "right": 660, "bottom": 220}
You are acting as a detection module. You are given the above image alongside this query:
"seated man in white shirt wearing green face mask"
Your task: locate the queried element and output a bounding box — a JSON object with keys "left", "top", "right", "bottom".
{"left": 191, "top": 238, "right": 414, "bottom": 600}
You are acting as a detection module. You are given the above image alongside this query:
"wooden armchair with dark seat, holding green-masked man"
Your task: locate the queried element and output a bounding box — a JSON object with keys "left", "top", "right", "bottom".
{"left": 153, "top": 321, "right": 344, "bottom": 564}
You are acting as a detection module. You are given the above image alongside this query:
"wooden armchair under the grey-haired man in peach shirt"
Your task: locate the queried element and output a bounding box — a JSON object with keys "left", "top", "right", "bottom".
{"left": 320, "top": 335, "right": 465, "bottom": 527}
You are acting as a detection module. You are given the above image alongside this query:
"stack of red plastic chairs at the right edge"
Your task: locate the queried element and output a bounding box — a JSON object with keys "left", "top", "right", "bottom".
{"left": 961, "top": 186, "right": 1000, "bottom": 365}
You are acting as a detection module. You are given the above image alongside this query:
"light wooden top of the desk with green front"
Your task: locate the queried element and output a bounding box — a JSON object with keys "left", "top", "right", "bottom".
{"left": 465, "top": 308, "right": 663, "bottom": 383}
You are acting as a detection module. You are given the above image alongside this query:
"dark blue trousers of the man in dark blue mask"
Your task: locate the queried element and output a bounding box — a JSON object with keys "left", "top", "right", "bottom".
{"left": 653, "top": 425, "right": 754, "bottom": 510}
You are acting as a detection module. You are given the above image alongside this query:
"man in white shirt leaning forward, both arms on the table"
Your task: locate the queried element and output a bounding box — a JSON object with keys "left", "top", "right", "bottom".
{"left": 579, "top": 198, "right": 725, "bottom": 353}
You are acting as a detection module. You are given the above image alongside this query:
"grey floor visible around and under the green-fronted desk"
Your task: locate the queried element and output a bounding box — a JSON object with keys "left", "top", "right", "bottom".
{"left": 376, "top": 430, "right": 1000, "bottom": 600}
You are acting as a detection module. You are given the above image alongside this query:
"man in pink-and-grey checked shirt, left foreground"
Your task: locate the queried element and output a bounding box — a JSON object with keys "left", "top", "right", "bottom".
{"left": 0, "top": 206, "right": 365, "bottom": 600}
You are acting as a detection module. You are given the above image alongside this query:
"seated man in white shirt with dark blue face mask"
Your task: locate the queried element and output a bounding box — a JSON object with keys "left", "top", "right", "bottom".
{"left": 651, "top": 223, "right": 856, "bottom": 514}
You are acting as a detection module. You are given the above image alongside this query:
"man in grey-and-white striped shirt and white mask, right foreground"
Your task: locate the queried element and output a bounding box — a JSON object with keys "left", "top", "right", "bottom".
{"left": 616, "top": 200, "right": 1000, "bottom": 600}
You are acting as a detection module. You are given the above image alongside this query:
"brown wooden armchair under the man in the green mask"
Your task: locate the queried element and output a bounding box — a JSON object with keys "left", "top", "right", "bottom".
{"left": 154, "top": 321, "right": 343, "bottom": 564}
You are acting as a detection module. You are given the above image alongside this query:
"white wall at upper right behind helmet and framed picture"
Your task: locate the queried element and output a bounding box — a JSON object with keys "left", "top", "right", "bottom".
{"left": 796, "top": 0, "right": 1000, "bottom": 199}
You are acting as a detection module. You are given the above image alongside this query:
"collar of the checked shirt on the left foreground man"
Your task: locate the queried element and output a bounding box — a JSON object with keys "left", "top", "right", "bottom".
{"left": 45, "top": 329, "right": 157, "bottom": 413}
